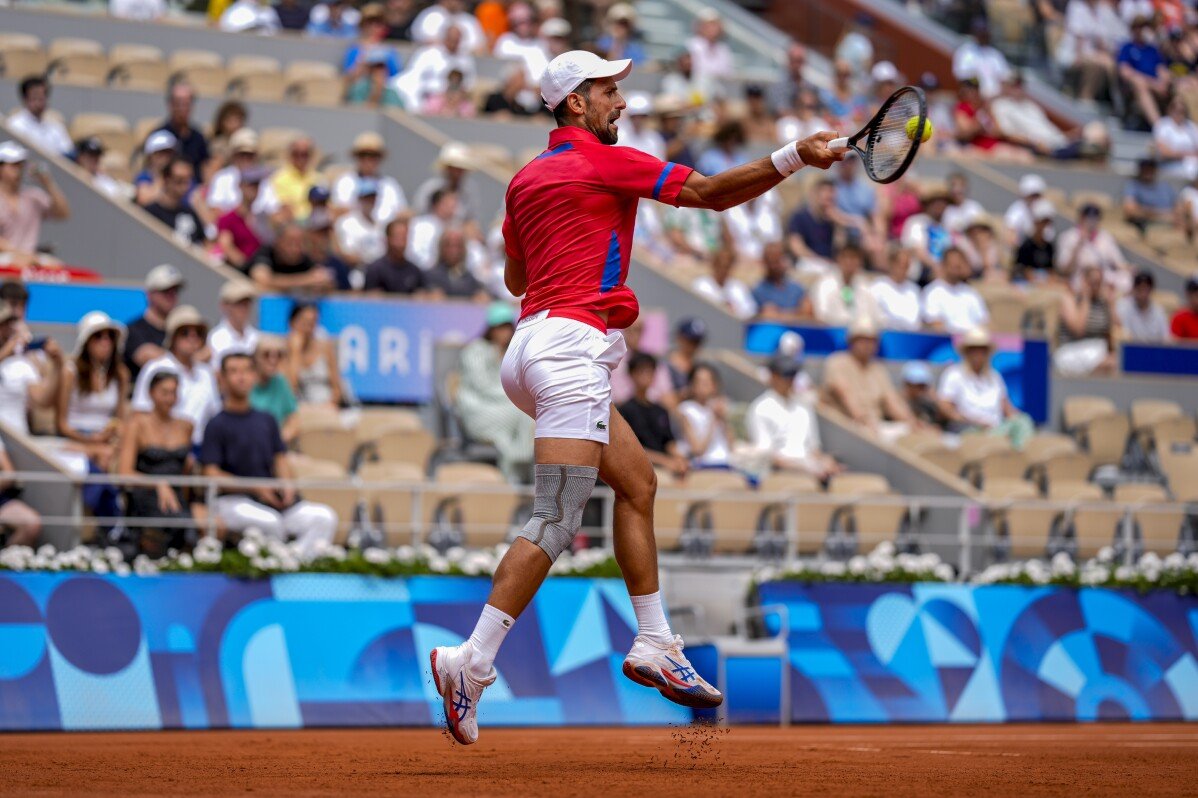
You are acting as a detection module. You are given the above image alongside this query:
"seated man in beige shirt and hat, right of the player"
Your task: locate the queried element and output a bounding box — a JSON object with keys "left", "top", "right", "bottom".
{"left": 823, "top": 319, "right": 913, "bottom": 442}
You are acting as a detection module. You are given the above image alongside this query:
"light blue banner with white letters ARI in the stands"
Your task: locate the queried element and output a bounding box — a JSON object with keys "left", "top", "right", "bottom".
{"left": 259, "top": 296, "right": 486, "bottom": 403}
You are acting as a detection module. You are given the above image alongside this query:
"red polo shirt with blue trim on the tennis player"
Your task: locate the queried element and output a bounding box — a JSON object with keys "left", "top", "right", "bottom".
{"left": 503, "top": 127, "right": 692, "bottom": 332}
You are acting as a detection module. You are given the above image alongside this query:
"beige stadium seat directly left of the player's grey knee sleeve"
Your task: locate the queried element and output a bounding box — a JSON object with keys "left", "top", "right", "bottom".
{"left": 424, "top": 463, "right": 520, "bottom": 548}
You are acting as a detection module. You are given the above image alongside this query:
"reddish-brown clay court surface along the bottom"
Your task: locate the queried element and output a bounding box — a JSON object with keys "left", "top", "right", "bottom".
{"left": 0, "top": 724, "right": 1198, "bottom": 798}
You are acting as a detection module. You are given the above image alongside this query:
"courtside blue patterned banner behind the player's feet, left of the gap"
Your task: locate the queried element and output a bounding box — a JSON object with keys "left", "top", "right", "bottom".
{"left": 0, "top": 573, "right": 691, "bottom": 730}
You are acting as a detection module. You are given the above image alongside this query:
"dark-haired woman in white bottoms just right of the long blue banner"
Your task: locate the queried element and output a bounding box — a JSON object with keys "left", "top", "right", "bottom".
{"left": 1053, "top": 264, "right": 1119, "bottom": 376}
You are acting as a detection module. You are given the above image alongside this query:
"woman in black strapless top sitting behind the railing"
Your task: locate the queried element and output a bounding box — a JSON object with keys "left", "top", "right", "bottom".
{"left": 120, "top": 370, "right": 201, "bottom": 557}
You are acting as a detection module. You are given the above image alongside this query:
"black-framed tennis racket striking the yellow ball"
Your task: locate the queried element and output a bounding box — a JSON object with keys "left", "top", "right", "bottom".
{"left": 828, "top": 86, "right": 927, "bottom": 183}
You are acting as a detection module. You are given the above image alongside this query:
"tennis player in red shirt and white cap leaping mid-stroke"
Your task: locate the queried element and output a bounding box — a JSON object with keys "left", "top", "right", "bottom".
{"left": 430, "top": 50, "right": 843, "bottom": 744}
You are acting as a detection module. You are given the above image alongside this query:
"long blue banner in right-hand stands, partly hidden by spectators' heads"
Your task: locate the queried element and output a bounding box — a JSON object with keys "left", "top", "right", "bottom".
{"left": 745, "top": 322, "right": 1051, "bottom": 424}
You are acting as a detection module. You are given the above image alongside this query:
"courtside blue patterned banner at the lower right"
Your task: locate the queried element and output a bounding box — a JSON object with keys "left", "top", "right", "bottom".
{"left": 752, "top": 581, "right": 1198, "bottom": 723}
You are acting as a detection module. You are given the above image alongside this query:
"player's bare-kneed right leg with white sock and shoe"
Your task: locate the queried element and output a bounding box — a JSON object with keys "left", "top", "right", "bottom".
{"left": 599, "top": 407, "right": 724, "bottom": 708}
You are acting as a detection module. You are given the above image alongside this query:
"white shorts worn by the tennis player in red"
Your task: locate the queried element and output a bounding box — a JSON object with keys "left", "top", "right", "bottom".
{"left": 501, "top": 310, "right": 627, "bottom": 443}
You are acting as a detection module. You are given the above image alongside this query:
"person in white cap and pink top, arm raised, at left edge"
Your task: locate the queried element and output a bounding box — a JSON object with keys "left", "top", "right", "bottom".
{"left": 0, "top": 141, "right": 71, "bottom": 266}
